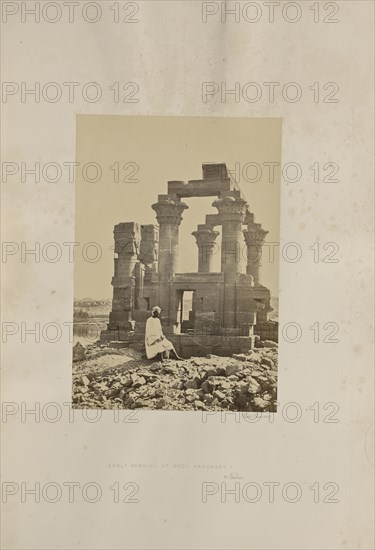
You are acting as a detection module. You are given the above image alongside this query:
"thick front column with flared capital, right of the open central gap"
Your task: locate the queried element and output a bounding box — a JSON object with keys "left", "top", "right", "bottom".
{"left": 212, "top": 196, "right": 247, "bottom": 276}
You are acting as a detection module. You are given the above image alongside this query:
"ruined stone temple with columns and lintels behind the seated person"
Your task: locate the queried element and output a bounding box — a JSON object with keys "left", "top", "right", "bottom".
{"left": 100, "top": 164, "right": 277, "bottom": 357}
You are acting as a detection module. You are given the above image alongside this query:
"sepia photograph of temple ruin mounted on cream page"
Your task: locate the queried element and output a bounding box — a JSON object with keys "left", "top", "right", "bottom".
{"left": 73, "top": 116, "right": 281, "bottom": 412}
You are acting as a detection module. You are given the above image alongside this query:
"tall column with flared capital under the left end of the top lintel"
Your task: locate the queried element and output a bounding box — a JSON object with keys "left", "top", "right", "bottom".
{"left": 152, "top": 195, "right": 188, "bottom": 276}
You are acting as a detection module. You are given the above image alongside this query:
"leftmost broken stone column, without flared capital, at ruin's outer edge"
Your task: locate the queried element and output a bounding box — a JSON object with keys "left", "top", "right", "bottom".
{"left": 109, "top": 222, "right": 141, "bottom": 330}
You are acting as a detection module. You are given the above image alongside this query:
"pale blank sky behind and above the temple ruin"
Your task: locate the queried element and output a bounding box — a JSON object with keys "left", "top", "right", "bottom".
{"left": 75, "top": 115, "right": 281, "bottom": 299}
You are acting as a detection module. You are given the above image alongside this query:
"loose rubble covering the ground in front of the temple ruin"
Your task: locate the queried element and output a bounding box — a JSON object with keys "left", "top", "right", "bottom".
{"left": 73, "top": 341, "right": 277, "bottom": 412}
